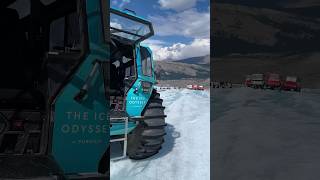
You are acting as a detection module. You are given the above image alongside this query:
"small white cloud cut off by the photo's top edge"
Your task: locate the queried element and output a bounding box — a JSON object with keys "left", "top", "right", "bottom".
{"left": 158, "top": 0, "right": 197, "bottom": 11}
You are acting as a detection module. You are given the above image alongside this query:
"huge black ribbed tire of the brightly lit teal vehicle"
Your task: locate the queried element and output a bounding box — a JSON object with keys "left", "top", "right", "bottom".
{"left": 127, "top": 91, "right": 166, "bottom": 160}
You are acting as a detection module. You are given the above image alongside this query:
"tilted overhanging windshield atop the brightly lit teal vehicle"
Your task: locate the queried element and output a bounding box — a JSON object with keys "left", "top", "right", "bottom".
{"left": 110, "top": 9, "right": 153, "bottom": 43}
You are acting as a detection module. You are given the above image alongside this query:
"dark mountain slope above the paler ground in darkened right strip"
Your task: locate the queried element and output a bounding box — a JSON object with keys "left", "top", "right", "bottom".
{"left": 211, "top": 3, "right": 320, "bottom": 56}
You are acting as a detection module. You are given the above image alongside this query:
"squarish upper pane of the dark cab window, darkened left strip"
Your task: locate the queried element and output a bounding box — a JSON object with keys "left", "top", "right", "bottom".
{"left": 49, "top": 12, "right": 81, "bottom": 53}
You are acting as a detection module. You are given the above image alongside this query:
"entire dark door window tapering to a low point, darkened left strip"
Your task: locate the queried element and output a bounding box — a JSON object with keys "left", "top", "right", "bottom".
{"left": 47, "top": 9, "right": 86, "bottom": 95}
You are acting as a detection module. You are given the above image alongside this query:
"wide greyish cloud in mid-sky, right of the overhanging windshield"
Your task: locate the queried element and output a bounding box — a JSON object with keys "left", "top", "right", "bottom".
{"left": 149, "top": 8, "right": 210, "bottom": 38}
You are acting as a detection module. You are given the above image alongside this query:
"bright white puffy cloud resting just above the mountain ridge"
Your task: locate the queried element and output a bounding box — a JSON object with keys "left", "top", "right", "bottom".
{"left": 143, "top": 38, "right": 210, "bottom": 60}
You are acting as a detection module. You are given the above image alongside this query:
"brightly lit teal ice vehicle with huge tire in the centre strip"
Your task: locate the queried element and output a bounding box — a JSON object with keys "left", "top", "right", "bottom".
{"left": 109, "top": 8, "right": 166, "bottom": 159}
